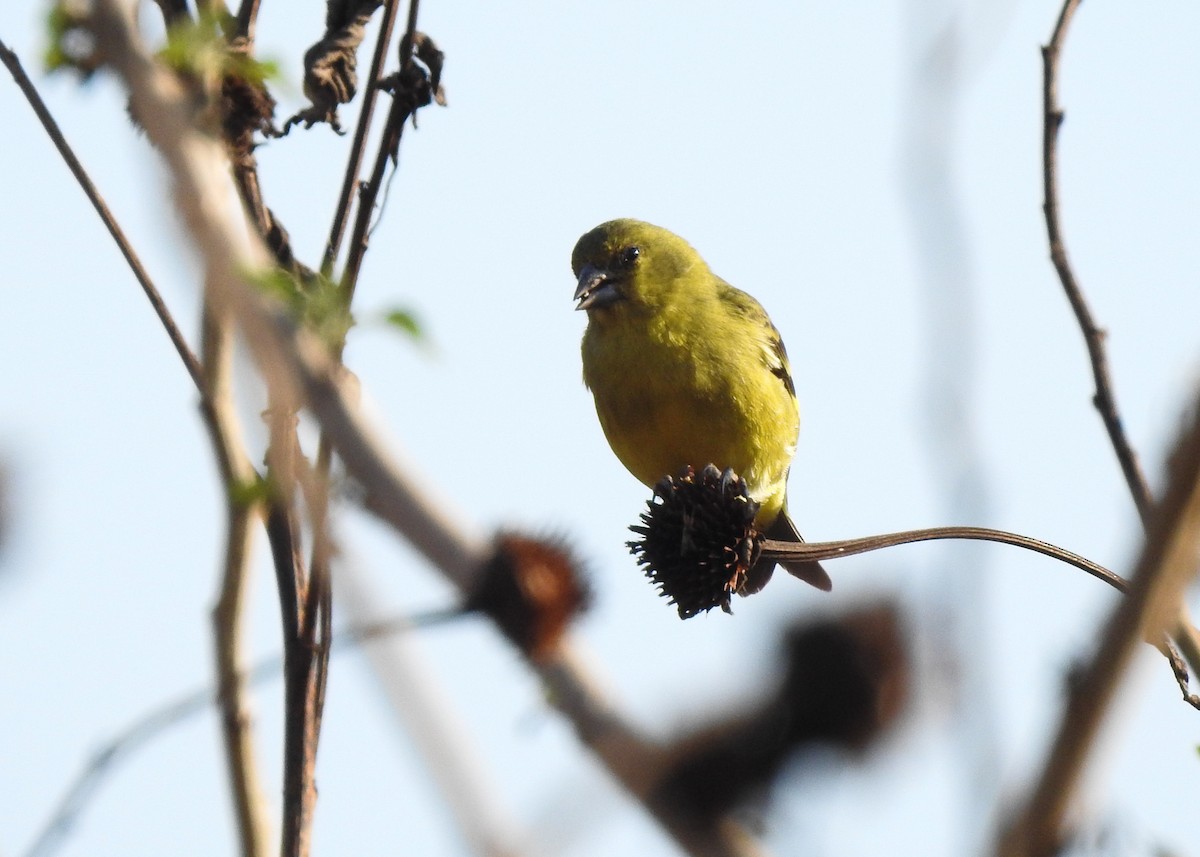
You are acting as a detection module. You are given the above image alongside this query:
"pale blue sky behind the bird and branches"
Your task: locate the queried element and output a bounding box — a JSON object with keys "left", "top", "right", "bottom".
{"left": 0, "top": 0, "right": 1200, "bottom": 857}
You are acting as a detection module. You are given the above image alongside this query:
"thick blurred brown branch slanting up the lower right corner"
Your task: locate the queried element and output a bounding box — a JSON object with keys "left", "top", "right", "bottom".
{"left": 1000, "top": 401, "right": 1200, "bottom": 857}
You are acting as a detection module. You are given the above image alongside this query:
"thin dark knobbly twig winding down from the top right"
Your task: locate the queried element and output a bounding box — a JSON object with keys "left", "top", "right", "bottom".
{"left": 1042, "top": 0, "right": 1200, "bottom": 699}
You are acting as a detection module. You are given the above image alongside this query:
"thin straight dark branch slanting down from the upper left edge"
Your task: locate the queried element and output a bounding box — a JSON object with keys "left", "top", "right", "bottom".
{"left": 0, "top": 35, "right": 204, "bottom": 391}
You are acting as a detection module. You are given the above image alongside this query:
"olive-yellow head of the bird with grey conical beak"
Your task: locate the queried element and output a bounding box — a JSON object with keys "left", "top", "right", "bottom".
{"left": 571, "top": 220, "right": 707, "bottom": 314}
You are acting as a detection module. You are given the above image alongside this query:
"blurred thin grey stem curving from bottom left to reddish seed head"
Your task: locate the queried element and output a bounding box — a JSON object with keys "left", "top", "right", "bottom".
{"left": 25, "top": 606, "right": 466, "bottom": 857}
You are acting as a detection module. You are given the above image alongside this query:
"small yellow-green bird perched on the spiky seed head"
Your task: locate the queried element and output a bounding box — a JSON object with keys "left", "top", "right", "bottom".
{"left": 571, "top": 218, "right": 833, "bottom": 595}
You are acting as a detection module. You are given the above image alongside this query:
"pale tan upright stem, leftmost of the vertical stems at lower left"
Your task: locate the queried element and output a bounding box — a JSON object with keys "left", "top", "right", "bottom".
{"left": 203, "top": 305, "right": 270, "bottom": 857}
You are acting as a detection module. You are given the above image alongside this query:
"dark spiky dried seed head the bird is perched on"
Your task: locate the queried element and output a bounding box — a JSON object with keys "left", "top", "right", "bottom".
{"left": 628, "top": 465, "right": 760, "bottom": 619}
